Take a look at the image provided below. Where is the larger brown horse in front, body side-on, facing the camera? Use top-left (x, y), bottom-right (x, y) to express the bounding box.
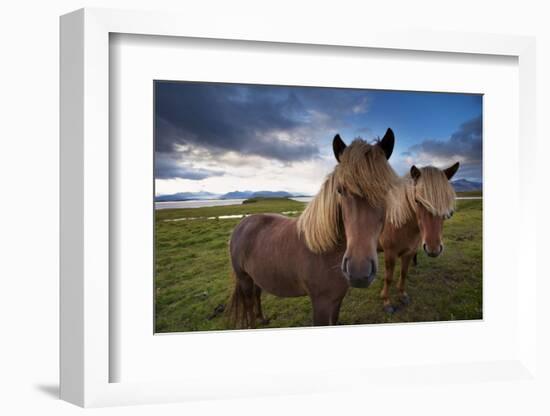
top-left (229, 129), bottom-right (398, 328)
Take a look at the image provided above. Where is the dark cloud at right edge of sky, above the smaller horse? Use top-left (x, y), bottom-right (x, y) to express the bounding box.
top-left (406, 116), bottom-right (482, 179)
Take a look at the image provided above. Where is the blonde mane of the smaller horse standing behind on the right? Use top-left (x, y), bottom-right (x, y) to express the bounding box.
top-left (386, 166), bottom-right (456, 227)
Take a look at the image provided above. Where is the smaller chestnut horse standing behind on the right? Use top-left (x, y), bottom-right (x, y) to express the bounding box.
top-left (378, 162), bottom-right (459, 313)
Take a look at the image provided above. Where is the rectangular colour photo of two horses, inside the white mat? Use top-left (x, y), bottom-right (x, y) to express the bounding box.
top-left (153, 80), bottom-right (483, 333)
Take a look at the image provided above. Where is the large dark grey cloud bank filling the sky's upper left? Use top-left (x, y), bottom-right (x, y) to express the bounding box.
top-left (155, 82), bottom-right (374, 173)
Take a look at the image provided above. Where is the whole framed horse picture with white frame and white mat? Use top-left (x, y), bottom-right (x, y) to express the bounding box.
top-left (61, 9), bottom-right (538, 406)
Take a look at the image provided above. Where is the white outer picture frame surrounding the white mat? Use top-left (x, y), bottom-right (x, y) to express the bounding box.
top-left (60, 9), bottom-right (538, 407)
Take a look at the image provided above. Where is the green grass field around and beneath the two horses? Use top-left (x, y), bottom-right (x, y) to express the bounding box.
top-left (155, 196), bottom-right (483, 332)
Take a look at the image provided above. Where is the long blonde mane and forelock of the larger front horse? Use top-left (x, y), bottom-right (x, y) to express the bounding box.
top-left (297, 139), bottom-right (399, 253)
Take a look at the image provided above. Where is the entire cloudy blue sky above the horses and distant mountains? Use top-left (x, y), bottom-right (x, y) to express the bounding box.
top-left (155, 81), bottom-right (482, 195)
